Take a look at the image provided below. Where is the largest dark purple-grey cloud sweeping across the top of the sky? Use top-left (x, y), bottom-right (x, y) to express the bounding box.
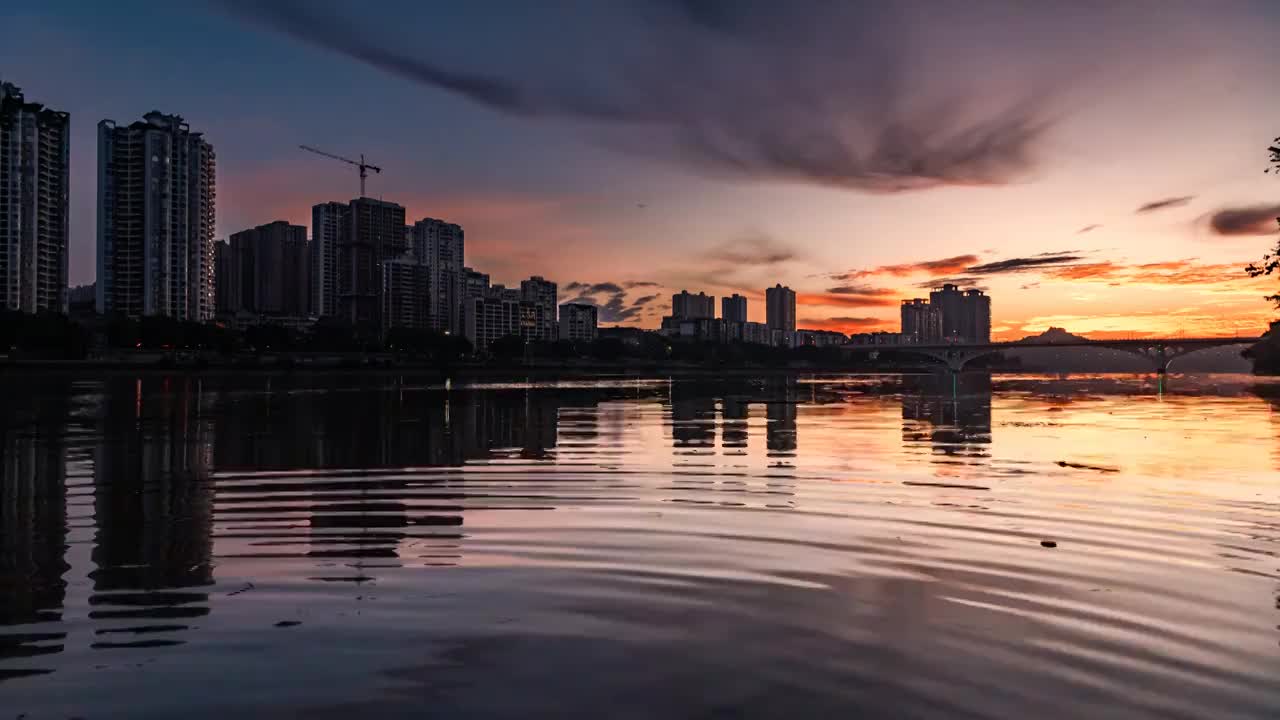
top-left (216, 0), bottom-right (1092, 192)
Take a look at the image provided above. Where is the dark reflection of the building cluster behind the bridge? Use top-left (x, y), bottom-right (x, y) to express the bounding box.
top-left (902, 373), bottom-right (992, 459)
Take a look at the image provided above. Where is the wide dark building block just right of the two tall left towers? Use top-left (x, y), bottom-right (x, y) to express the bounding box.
top-left (216, 220), bottom-right (311, 318)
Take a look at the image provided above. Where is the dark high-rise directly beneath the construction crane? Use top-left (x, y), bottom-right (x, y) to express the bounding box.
top-left (337, 197), bottom-right (406, 332)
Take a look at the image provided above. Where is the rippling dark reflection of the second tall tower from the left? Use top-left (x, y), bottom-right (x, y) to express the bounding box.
top-left (88, 378), bottom-right (214, 650)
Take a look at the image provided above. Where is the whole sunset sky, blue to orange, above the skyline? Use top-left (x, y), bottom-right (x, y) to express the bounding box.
top-left (0, 0), bottom-right (1280, 340)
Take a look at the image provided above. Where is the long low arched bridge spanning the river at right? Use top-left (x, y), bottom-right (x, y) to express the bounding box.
top-left (842, 337), bottom-right (1262, 374)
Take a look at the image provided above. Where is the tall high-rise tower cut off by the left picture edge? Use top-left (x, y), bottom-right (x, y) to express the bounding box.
top-left (0, 82), bottom-right (70, 313)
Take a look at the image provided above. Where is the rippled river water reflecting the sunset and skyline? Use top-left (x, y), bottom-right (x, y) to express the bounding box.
top-left (0, 374), bottom-right (1280, 720)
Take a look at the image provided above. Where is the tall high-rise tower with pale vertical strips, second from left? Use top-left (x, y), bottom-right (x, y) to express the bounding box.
top-left (97, 110), bottom-right (216, 316)
